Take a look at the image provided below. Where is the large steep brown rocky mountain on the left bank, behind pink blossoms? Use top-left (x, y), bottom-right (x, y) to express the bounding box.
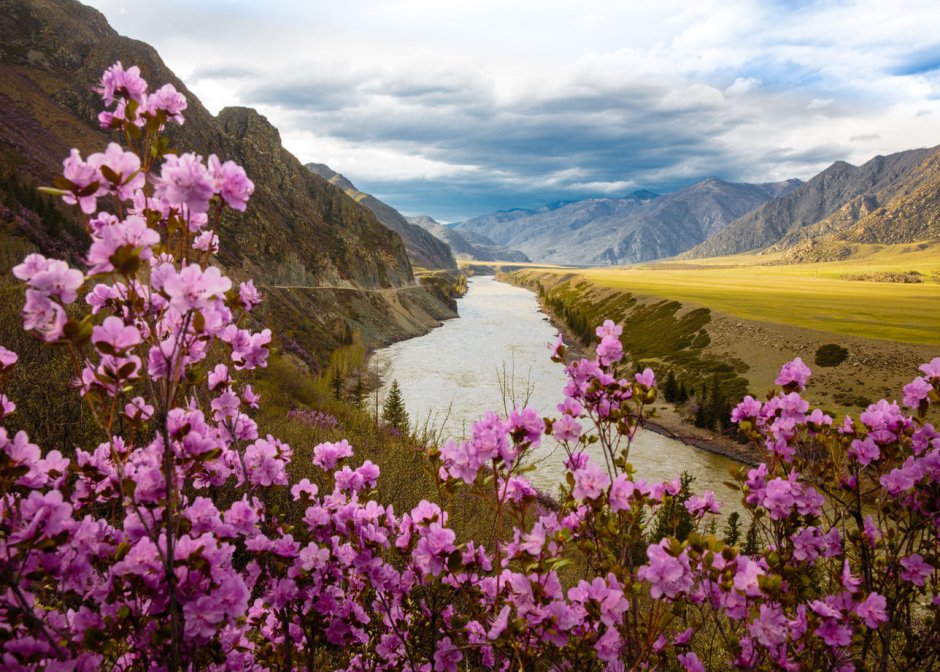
top-left (0, 0), bottom-right (454, 366)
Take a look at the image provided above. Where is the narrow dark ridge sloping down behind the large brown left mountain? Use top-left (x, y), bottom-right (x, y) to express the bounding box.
top-left (306, 163), bottom-right (457, 270)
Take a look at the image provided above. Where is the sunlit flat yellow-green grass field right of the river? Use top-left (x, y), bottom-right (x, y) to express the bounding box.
top-left (510, 242), bottom-right (940, 345)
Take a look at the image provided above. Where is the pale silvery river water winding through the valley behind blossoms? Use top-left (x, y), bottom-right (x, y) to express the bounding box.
top-left (374, 276), bottom-right (741, 513)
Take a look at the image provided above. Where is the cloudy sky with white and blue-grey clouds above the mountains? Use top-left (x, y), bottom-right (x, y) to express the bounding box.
top-left (85, 0), bottom-right (940, 221)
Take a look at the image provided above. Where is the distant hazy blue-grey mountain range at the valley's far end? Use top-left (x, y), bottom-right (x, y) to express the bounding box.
top-left (456, 178), bottom-right (801, 265)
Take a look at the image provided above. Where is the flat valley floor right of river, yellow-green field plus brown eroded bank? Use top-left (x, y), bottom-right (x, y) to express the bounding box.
top-left (494, 243), bottom-right (940, 414)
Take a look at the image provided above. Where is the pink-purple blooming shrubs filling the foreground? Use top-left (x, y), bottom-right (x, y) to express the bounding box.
top-left (0, 63), bottom-right (940, 672)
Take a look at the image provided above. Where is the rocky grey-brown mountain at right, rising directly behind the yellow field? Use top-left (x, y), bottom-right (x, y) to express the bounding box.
top-left (683, 148), bottom-right (940, 258)
